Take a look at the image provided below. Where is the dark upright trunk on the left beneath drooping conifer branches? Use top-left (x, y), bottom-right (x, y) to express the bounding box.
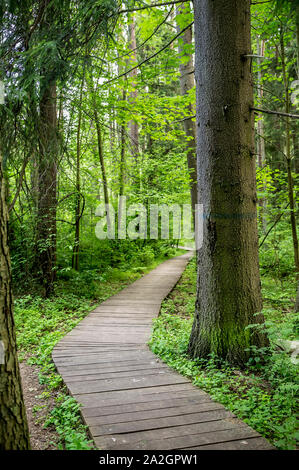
top-left (37, 82), bottom-right (57, 297)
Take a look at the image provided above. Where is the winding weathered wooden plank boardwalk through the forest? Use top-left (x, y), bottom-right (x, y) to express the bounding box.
top-left (53, 252), bottom-right (272, 450)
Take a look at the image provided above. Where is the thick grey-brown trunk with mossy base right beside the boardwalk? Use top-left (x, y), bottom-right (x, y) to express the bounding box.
top-left (189, 0), bottom-right (267, 366)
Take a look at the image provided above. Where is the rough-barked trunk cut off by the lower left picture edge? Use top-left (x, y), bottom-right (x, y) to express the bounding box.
top-left (0, 152), bottom-right (30, 450)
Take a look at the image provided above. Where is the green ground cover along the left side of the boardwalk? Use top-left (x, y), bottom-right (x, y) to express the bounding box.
top-left (14, 244), bottom-right (182, 450)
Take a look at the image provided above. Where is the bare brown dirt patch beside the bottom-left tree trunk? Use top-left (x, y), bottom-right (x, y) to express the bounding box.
top-left (20, 361), bottom-right (58, 450)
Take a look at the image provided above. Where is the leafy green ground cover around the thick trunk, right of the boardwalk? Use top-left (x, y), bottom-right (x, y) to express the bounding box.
top-left (149, 259), bottom-right (299, 449)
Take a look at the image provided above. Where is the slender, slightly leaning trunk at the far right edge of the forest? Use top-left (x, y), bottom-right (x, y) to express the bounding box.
top-left (280, 25), bottom-right (299, 273)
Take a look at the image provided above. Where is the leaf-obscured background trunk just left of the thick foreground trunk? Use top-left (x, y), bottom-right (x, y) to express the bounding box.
top-left (177, 3), bottom-right (198, 218)
